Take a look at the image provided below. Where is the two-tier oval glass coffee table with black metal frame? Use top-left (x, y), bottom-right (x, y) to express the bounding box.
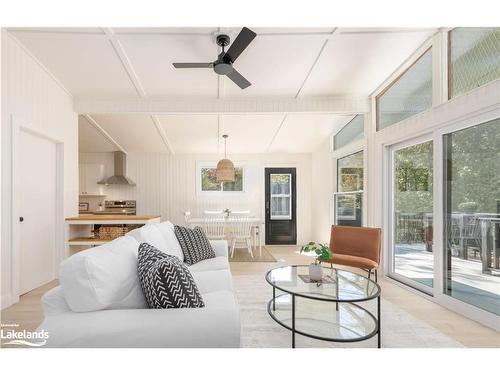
top-left (266, 266), bottom-right (380, 348)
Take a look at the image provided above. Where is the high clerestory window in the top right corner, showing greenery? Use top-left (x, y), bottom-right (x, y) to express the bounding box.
top-left (448, 27), bottom-right (500, 99)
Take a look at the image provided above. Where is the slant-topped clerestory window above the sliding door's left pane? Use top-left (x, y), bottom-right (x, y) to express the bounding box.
top-left (377, 49), bottom-right (432, 130)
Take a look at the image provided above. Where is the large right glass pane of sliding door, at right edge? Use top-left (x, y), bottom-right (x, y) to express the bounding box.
top-left (443, 119), bottom-right (500, 315)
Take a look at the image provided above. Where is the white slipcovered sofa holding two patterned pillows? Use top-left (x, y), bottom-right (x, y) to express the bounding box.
top-left (38, 222), bottom-right (240, 348)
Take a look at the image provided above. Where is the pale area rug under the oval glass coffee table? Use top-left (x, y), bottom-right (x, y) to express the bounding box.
top-left (234, 275), bottom-right (463, 348)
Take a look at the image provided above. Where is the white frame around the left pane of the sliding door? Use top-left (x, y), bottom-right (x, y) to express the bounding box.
top-left (384, 134), bottom-right (439, 296)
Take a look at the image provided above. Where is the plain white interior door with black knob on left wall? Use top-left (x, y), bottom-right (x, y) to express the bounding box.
top-left (19, 131), bottom-right (57, 294)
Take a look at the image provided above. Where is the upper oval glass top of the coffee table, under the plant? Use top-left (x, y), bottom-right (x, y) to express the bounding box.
top-left (266, 265), bottom-right (380, 302)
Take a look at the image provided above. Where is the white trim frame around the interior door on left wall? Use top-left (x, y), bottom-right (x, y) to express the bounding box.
top-left (10, 116), bottom-right (64, 304)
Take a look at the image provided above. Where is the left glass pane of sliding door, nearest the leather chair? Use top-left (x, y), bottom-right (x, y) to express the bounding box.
top-left (389, 141), bottom-right (434, 293)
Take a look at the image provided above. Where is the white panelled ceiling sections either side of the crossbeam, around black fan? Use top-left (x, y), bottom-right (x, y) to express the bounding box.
top-left (8, 27), bottom-right (436, 153)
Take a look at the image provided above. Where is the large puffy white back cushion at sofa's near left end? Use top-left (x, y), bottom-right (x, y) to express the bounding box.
top-left (59, 236), bottom-right (147, 312)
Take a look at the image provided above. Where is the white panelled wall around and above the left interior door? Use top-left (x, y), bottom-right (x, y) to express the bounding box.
top-left (1, 30), bottom-right (78, 308)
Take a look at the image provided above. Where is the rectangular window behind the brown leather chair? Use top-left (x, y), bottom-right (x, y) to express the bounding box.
top-left (334, 151), bottom-right (363, 227)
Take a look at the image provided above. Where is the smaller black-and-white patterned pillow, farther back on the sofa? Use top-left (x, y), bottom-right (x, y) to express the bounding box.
top-left (174, 225), bottom-right (215, 265)
